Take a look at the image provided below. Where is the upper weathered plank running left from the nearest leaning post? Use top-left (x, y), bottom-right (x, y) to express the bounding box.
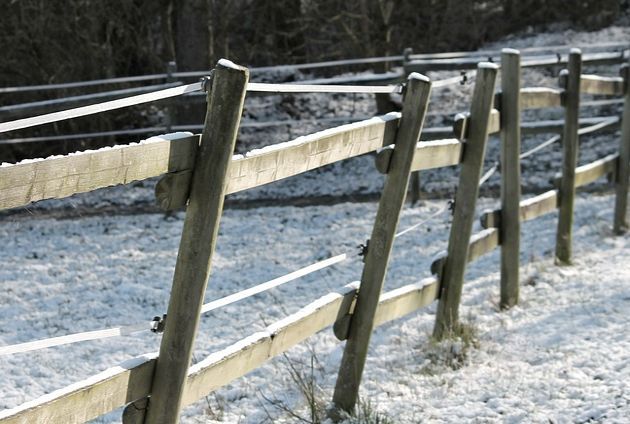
top-left (0, 133), bottom-right (199, 210)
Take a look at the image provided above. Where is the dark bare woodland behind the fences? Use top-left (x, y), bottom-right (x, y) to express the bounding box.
top-left (0, 0), bottom-right (630, 160)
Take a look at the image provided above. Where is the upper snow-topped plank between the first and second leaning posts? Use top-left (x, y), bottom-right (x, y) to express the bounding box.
top-left (156, 112), bottom-right (400, 210)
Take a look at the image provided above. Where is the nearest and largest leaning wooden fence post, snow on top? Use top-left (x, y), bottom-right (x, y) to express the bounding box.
top-left (145, 60), bottom-right (249, 424)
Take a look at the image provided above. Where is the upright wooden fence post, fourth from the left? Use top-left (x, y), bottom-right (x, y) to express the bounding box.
top-left (500, 49), bottom-right (521, 309)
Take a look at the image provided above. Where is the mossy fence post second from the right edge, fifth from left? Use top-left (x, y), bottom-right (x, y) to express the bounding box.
top-left (556, 49), bottom-right (582, 265)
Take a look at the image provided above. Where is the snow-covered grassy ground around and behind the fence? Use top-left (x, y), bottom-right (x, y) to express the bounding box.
top-left (0, 18), bottom-right (630, 423)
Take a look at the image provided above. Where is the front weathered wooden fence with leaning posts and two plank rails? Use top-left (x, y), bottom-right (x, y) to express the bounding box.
top-left (0, 50), bottom-right (630, 424)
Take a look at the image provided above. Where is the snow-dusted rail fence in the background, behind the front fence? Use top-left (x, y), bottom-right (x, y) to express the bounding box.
top-left (0, 43), bottom-right (630, 145)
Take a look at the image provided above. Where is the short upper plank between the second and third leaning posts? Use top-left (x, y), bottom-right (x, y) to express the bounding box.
top-left (375, 138), bottom-right (463, 174)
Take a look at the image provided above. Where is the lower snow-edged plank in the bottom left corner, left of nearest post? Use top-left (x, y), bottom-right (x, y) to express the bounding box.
top-left (0, 354), bottom-right (157, 424)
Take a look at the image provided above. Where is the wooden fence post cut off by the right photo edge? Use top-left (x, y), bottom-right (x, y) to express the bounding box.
top-left (613, 64), bottom-right (630, 234)
